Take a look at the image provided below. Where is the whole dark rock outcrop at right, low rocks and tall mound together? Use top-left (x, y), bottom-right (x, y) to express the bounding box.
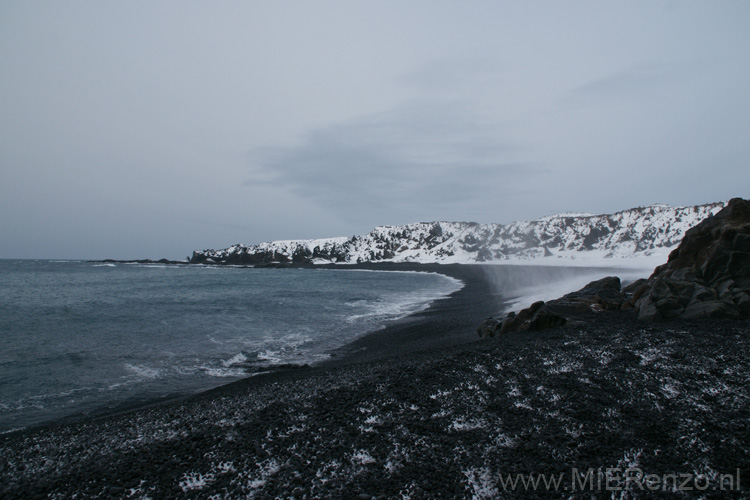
top-left (488, 198), bottom-right (750, 338)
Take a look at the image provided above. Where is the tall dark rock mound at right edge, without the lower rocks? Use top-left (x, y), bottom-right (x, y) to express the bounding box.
top-left (634, 198), bottom-right (750, 321)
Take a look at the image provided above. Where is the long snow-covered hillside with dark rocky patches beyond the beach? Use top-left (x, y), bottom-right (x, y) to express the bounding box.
top-left (190, 202), bottom-right (725, 267)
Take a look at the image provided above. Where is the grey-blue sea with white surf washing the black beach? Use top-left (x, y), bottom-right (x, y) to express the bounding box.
top-left (0, 260), bottom-right (462, 432)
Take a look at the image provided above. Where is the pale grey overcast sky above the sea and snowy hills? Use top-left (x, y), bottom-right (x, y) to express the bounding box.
top-left (0, 0), bottom-right (750, 259)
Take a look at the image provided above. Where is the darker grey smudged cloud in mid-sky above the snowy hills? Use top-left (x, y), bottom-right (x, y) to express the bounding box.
top-left (247, 102), bottom-right (537, 221)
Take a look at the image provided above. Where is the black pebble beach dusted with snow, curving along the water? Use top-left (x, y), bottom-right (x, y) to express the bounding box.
top-left (0, 265), bottom-right (750, 499)
